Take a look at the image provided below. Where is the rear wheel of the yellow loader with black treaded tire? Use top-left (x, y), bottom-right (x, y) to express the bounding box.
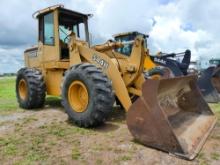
top-left (16, 68), bottom-right (46, 109)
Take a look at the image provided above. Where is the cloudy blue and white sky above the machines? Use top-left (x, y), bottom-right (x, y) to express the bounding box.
top-left (0, 0), bottom-right (220, 73)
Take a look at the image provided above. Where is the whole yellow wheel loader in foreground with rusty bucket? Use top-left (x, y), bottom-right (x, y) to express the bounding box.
top-left (16, 6), bottom-right (216, 159)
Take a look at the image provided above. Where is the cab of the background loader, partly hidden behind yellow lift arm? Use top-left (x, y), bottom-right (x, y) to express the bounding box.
top-left (113, 31), bottom-right (148, 56)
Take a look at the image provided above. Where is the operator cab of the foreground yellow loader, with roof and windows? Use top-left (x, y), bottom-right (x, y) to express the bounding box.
top-left (34, 5), bottom-right (90, 61)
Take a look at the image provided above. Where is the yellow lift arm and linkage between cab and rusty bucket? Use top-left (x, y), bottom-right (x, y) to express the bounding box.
top-left (69, 34), bottom-right (145, 111)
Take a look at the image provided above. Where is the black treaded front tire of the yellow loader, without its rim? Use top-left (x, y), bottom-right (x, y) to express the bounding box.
top-left (62, 63), bottom-right (115, 127)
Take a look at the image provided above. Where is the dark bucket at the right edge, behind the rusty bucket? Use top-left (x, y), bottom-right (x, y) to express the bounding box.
top-left (197, 67), bottom-right (220, 103)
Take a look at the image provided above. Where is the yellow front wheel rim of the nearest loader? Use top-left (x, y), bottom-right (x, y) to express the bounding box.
top-left (68, 81), bottom-right (89, 112)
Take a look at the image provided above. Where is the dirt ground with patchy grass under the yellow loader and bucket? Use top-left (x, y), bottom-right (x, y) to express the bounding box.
top-left (0, 102), bottom-right (220, 165)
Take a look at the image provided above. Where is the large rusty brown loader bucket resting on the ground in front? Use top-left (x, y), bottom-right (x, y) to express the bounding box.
top-left (126, 76), bottom-right (216, 160)
